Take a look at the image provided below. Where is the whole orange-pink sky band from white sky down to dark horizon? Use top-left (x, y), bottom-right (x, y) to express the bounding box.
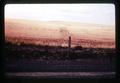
top-left (5, 19), bottom-right (115, 48)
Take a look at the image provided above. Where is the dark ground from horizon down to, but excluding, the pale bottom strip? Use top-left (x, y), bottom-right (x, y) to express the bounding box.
top-left (5, 43), bottom-right (116, 72)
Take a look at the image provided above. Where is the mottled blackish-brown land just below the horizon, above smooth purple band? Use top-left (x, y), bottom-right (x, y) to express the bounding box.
top-left (5, 39), bottom-right (116, 60)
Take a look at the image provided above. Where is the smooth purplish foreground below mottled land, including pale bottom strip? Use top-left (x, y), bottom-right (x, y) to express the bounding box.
top-left (5, 59), bottom-right (115, 78)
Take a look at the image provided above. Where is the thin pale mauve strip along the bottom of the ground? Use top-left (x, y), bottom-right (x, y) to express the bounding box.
top-left (6, 72), bottom-right (115, 79)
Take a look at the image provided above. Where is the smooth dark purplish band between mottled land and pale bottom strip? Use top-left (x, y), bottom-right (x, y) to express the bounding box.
top-left (5, 59), bottom-right (115, 72)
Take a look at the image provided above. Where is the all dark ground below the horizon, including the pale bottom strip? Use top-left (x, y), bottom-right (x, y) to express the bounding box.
top-left (4, 43), bottom-right (116, 78)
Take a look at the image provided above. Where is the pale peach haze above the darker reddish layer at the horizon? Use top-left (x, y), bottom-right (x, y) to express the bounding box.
top-left (5, 19), bottom-right (115, 48)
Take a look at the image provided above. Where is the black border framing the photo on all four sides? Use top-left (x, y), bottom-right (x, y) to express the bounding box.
top-left (0, 0), bottom-right (120, 83)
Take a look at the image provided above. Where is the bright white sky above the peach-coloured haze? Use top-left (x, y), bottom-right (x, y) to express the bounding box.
top-left (5, 4), bottom-right (115, 25)
